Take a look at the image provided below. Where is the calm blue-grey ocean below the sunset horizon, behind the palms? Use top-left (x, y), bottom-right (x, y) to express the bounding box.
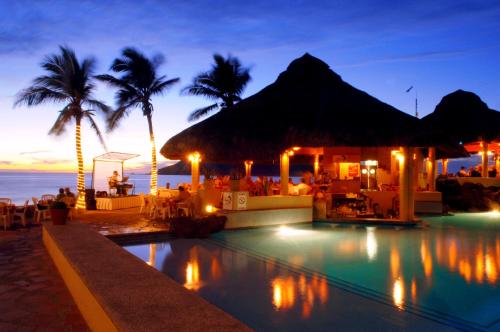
top-left (0, 156), bottom-right (484, 204)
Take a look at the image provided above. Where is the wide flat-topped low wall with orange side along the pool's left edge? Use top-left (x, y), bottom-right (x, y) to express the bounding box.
top-left (43, 222), bottom-right (251, 331)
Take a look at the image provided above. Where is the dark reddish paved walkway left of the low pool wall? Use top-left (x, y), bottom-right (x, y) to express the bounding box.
top-left (0, 226), bottom-right (88, 332)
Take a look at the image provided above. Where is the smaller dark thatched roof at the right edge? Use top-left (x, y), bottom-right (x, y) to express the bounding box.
top-left (422, 90), bottom-right (500, 144)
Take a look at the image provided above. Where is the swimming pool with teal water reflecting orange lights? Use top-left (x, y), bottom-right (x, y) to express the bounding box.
top-left (124, 213), bottom-right (500, 331)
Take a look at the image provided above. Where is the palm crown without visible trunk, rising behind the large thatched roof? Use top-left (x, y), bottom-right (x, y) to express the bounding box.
top-left (182, 54), bottom-right (251, 121)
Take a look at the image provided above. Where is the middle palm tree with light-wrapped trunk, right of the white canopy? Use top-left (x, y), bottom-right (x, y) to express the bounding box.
top-left (96, 47), bottom-right (179, 194)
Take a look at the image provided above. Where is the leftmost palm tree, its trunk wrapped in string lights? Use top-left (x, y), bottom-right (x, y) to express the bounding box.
top-left (14, 46), bottom-right (111, 208)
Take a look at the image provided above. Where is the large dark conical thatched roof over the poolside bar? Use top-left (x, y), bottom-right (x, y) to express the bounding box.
top-left (161, 54), bottom-right (428, 162)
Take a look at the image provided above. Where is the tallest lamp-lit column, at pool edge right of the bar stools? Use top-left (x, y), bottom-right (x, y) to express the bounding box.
top-left (398, 147), bottom-right (415, 221)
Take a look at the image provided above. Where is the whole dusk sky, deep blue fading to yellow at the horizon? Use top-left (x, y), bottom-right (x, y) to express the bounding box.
top-left (0, 0), bottom-right (500, 171)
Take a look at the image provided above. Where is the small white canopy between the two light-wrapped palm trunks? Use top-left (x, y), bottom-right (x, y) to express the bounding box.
top-left (92, 152), bottom-right (139, 191)
